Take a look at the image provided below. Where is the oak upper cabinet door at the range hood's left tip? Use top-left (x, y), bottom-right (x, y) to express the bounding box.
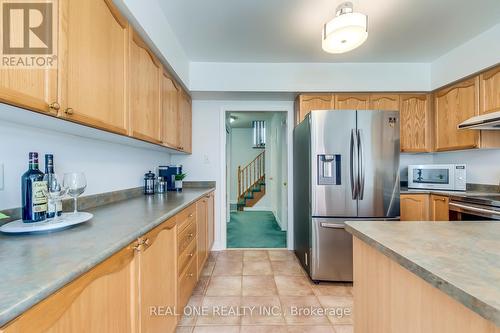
top-left (435, 76), bottom-right (479, 151)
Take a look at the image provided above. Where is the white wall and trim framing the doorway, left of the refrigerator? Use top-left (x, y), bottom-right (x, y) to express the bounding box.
top-left (172, 100), bottom-right (293, 249)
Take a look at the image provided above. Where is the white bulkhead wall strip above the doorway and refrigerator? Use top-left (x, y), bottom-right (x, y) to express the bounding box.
top-left (189, 62), bottom-right (431, 92)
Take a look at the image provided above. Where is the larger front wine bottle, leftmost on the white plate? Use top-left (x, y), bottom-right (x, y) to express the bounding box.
top-left (21, 152), bottom-right (47, 223)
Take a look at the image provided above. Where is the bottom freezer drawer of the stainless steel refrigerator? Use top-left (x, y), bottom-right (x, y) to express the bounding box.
top-left (310, 218), bottom-right (353, 282)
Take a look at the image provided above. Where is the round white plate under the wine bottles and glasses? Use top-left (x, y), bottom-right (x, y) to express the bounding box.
top-left (0, 212), bottom-right (94, 234)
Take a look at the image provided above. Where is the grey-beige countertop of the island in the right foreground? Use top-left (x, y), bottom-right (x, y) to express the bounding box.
top-left (346, 221), bottom-right (500, 326)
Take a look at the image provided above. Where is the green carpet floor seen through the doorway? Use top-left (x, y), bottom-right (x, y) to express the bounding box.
top-left (227, 211), bottom-right (286, 248)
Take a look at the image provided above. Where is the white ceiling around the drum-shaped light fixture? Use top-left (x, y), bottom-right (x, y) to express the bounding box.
top-left (159, 0), bottom-right (500, 62)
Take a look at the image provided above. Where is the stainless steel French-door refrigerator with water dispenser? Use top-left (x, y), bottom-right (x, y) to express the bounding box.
top-left (293, 110), bottom-right (400, 281)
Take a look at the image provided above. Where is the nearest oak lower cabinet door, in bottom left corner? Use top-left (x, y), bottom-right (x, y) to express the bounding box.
top-left (2, 246), bottom-right (138, 333)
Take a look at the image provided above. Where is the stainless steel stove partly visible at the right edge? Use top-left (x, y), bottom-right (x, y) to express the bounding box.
top-left (449, 194), bottom-right (500, 221)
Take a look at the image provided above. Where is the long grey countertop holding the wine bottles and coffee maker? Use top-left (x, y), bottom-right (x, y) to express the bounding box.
top-left (0, 186), bottom-right (215, 326)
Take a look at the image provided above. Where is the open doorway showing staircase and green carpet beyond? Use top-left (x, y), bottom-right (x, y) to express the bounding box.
top-left (225, 111), bottom-right (288, 248)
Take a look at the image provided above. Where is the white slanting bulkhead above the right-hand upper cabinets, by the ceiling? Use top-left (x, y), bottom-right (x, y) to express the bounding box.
top-left (431, 23), bottom-right (500, 89)
